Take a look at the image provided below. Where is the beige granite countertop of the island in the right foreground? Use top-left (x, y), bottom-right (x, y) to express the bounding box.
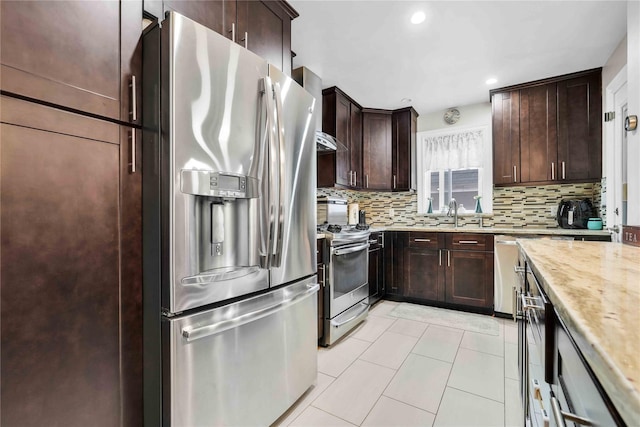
top-left (518, 240), bottom-right (640, 426)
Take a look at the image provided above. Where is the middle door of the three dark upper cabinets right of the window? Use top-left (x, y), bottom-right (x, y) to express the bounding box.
top-left (519, 83), bottom-right (558, 182)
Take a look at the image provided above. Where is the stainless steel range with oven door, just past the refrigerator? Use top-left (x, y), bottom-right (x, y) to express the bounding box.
top-left (318, 198), bottom-right (371, 346)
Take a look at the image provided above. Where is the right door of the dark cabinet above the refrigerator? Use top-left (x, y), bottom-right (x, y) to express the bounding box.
top-left (236, 0), bottom-right (292, 75)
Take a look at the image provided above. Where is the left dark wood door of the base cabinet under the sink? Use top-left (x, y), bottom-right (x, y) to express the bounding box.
top-left (404, 248), bottom-right (444, 301)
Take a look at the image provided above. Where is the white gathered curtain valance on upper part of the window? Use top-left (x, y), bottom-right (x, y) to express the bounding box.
top-left (421, 129), bottom-right (484, 172)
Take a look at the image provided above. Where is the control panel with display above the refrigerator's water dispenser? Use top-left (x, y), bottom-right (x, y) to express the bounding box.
top-left (180, 170), bottom-right (260, 199)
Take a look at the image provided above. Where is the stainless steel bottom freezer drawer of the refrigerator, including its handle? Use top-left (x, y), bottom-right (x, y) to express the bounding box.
top-left (162, 276), bottom-right (319, 427)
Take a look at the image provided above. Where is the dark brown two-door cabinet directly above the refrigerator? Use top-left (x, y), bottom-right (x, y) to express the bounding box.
top-left (162, 0), bottom-right (298, 75)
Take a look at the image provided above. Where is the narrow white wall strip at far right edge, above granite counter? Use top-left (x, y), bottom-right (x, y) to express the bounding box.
top-left (627, 1), bottom-right (640, 225)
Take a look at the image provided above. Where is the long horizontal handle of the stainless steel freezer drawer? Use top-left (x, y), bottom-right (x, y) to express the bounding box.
top-left (182, 283), bottom-right (320, 342)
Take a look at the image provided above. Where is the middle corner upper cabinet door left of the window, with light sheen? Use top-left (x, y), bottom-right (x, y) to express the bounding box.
top-left (362, 112), bottom-right (392, 190)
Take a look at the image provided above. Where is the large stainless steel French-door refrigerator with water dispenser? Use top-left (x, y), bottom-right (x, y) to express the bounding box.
top-left (143, 12), bottom-right (318, 426)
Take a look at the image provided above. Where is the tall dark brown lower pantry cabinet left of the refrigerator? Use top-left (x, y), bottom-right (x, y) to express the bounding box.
top-left (0, 97), bottom-right (142, 427)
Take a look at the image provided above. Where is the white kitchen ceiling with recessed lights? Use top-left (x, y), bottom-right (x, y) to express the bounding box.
top-left (289, 0), bottom-right (627, 114)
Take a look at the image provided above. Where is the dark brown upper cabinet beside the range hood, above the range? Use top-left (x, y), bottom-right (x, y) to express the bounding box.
top-left (318, 86), bottom-right (362, 188)
